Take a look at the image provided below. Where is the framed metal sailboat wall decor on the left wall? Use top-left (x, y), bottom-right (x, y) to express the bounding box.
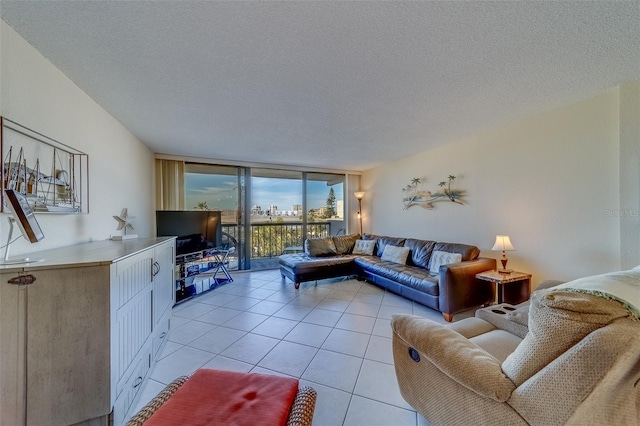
top-left (0, 117), bottom-right (89, 214)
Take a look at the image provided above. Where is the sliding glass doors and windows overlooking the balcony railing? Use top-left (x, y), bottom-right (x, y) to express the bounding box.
top-left (158, 160), bottom-right (347, 270)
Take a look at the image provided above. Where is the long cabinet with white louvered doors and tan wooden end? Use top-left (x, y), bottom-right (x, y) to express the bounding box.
top-left (0, 238), bottom-right (175, 426)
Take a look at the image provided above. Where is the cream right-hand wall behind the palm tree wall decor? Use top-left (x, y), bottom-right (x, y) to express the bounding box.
top-left (362, 89), bottom-right (640, 286)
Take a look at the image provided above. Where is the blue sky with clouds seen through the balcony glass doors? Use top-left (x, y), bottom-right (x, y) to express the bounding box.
top-left (185, 173), bottom-right (344, 210)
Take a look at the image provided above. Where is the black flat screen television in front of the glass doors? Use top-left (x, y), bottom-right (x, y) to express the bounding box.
top-left (156, 210), bottom-right (222, 254)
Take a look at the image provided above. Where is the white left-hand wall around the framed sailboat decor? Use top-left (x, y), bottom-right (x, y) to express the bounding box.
top-left (0, 21), bottom-right (155, 255)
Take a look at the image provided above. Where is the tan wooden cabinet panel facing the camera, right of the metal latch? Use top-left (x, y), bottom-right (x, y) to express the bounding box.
top-left (26, 266), bottom-right (111, 425)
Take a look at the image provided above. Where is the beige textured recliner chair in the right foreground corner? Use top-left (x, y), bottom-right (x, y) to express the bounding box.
top-left (391, 273), bottom-right (640, 426)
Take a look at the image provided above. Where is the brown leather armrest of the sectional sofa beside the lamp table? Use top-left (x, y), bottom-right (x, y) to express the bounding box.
top-left (438, 257), bottom-right (496, 314)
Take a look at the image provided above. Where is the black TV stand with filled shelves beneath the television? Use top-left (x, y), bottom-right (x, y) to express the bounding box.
top-left (175, 248), bottom-right (233, 304)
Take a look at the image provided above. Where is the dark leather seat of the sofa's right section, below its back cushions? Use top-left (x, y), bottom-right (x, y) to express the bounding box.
top-left (355, 256), bottom-right (439, 296)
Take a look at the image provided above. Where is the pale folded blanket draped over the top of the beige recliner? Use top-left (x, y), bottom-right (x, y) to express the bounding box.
top-left (555, 269), bottom-right (640, 320)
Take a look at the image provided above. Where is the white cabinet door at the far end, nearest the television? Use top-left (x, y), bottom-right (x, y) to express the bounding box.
top-left (153, 240), bottom-right (175, 327)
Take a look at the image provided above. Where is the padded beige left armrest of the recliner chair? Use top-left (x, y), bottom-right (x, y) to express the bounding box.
top-left (391, 315), bottom-right (515, 402)
